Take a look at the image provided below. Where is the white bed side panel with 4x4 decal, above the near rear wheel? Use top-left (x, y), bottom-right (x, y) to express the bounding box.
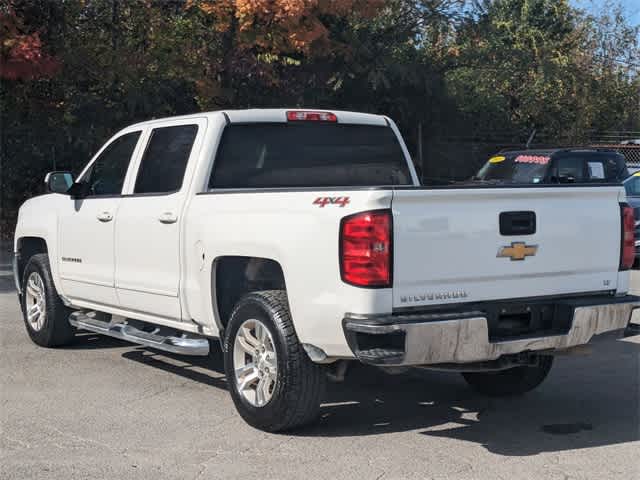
top-left (185, 190), bottom-right (392, 357)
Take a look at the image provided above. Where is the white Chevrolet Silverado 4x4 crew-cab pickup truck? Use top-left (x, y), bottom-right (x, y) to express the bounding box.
top-left (14, 109), bottom-right (640, 431)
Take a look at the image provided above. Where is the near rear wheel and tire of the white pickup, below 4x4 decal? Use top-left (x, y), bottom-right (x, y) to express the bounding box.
top-left (224, 290), bottom-right (326, 432)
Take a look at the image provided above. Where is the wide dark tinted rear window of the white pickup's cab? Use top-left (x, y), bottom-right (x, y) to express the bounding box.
top-left (209, 123), bottom-right (411, 189)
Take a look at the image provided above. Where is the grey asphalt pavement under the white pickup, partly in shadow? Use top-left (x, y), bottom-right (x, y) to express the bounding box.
top-left (0, 248), bottom-right (640, 480)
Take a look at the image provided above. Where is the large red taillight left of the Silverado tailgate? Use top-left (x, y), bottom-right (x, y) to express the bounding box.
top-left (340, 210), bottom-right (393, 288)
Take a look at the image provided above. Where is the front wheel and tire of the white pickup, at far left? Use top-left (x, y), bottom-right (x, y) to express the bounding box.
top-left (21, 253), bottom-right (75, 347)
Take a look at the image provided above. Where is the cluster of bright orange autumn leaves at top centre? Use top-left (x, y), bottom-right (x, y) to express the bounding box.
top-left (187, 0), bottom-right (384, 55)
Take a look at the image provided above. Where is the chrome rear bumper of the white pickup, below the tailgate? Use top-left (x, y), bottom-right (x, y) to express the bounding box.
top-left (343, 295), bottom-right (640, 366)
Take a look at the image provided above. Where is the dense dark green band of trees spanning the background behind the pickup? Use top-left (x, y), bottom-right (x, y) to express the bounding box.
top-left (0, 0), bottom-right (640, 236)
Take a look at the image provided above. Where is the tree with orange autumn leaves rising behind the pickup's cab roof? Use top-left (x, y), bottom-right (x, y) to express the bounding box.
top-left (186, 0), bottom-right (384, 109)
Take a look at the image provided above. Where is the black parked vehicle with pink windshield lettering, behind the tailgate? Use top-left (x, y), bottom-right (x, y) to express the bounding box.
top-left (474, 149), bottom-right (629, 184)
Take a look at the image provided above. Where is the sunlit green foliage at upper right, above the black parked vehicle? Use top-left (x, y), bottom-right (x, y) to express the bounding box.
top-left (446, 0), bottom-right (639, 141)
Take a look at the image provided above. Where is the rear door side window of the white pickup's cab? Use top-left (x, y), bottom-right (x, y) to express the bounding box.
top-left (133, 125), bottom-right (198, 194)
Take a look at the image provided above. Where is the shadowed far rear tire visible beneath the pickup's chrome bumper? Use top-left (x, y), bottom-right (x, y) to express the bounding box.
top-left (462, 355), bottom-right (553, 397)
